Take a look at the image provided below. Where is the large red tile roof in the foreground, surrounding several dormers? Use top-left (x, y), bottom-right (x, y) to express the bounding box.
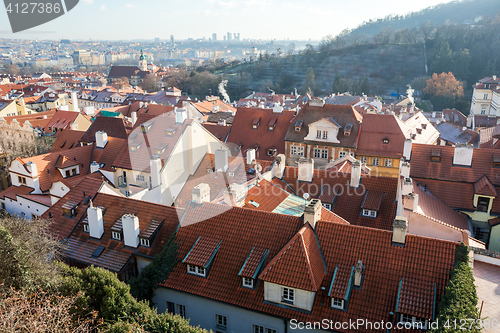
top-left (161, 203), bottom-right (458, 331)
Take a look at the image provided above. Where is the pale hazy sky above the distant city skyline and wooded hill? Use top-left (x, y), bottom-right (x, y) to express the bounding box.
top-left (0, 0), bottom-right (451, 40)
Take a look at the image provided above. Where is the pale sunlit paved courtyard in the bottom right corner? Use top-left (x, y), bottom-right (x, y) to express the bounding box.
top-left (474, 260), bottom-right (500, 333)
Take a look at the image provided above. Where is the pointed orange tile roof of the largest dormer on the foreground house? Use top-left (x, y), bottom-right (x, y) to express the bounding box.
top-left (259, 223), bottom-right (327, 292)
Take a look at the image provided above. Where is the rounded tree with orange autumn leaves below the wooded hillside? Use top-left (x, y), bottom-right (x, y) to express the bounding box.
top-left (424, 72), bottom-right (464, 110)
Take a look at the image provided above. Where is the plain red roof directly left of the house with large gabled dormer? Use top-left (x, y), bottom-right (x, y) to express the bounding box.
top-left (227, 107), bottom-right (295, 161)
